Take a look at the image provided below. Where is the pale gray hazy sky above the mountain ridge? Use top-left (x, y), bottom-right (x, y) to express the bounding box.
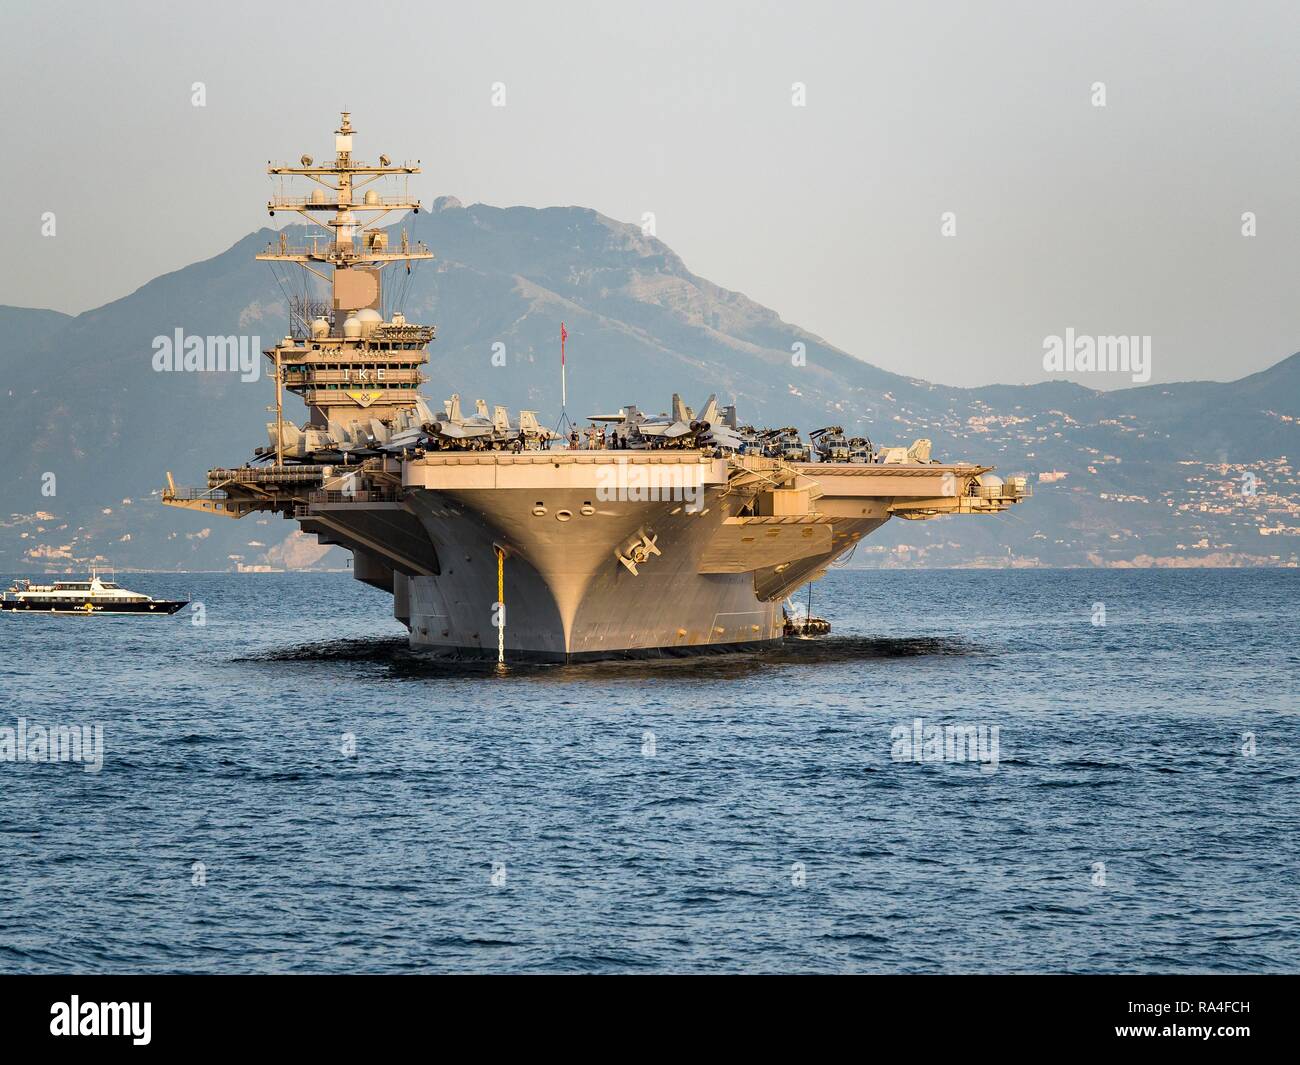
top-left (0, 0), bottom-right (1300, 388)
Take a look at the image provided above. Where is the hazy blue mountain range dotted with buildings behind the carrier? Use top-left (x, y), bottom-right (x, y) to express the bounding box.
top-left (0, 196), bottom-right (1300, 572)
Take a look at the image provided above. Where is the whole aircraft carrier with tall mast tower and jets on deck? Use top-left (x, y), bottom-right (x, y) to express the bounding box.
top-left (163, 113), bottom-right (1028, 662)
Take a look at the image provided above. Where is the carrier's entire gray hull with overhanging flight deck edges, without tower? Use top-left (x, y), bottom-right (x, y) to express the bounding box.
top-left (295, 451), bottom-right (1013, 662)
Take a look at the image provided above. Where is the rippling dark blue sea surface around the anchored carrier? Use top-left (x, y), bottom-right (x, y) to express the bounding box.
top-left (0, 570), bottom-right (1300, 973)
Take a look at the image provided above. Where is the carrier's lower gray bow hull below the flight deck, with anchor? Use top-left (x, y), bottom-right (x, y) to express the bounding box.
top-left (407, 489), bottom-right (783, 661)
